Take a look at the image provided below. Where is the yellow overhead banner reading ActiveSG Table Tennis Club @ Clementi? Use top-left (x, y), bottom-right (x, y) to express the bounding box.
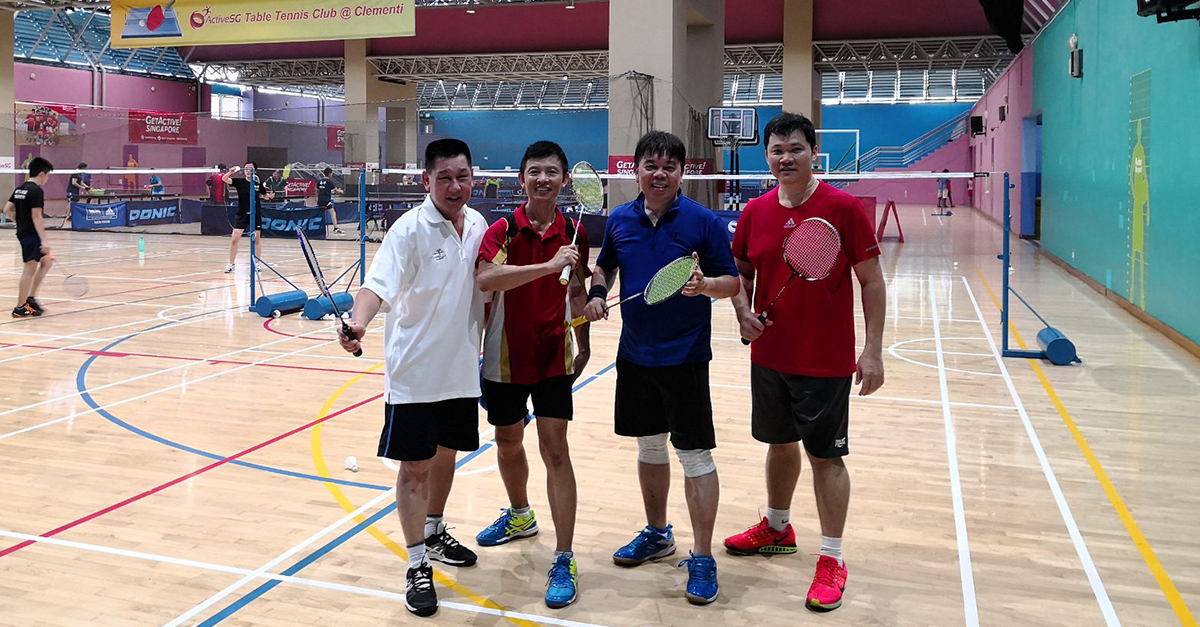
top-left (112, 0), bottom-right (416, 48)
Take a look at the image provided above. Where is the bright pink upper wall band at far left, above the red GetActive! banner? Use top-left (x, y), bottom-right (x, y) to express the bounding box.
top-left (13, 64), bottom-right (196, 112)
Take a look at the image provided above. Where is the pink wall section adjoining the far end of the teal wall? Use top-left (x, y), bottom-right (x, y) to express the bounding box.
top-left (955, 46), bottom-right (1034, 231)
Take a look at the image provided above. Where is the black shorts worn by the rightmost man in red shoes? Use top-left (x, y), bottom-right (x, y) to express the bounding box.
top-left (750, 364), bottom-right (853, 458)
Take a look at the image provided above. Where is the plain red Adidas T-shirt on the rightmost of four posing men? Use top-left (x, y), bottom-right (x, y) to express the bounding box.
top-left (733, 183), bottom-right (880, 377)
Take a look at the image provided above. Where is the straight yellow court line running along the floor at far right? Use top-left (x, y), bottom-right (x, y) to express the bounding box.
top-left (979, 265), bottom-right (1200, 627)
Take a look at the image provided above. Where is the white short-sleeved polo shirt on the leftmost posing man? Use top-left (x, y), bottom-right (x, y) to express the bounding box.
top-left (364, 196), bottom-right (487, 405)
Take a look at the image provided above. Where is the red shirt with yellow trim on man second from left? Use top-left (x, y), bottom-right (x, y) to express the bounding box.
top-left (475, 204), bottom-right (588, 386)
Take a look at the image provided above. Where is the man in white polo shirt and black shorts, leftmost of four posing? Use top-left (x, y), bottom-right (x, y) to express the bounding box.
top-left (341, 139), bottom-right (487, 616)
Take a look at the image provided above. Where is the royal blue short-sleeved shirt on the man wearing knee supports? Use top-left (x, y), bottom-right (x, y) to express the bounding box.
top-left (596, 190), bottom-right (738, 366)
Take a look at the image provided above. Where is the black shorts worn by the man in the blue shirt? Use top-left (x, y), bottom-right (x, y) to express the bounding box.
top-left (613, 357), bottom-right (716, 450)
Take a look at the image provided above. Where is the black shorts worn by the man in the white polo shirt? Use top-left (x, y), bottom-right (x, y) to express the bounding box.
top-left (378, 398), bottom-right (479, 461)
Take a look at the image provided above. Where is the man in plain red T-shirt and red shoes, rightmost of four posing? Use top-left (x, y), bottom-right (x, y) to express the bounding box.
top-left (725, 113), bottom-right (887, 610)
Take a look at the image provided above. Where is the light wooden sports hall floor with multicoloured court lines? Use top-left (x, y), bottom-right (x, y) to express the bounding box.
top-left (0, 205), bottom-right (1200, 627)
